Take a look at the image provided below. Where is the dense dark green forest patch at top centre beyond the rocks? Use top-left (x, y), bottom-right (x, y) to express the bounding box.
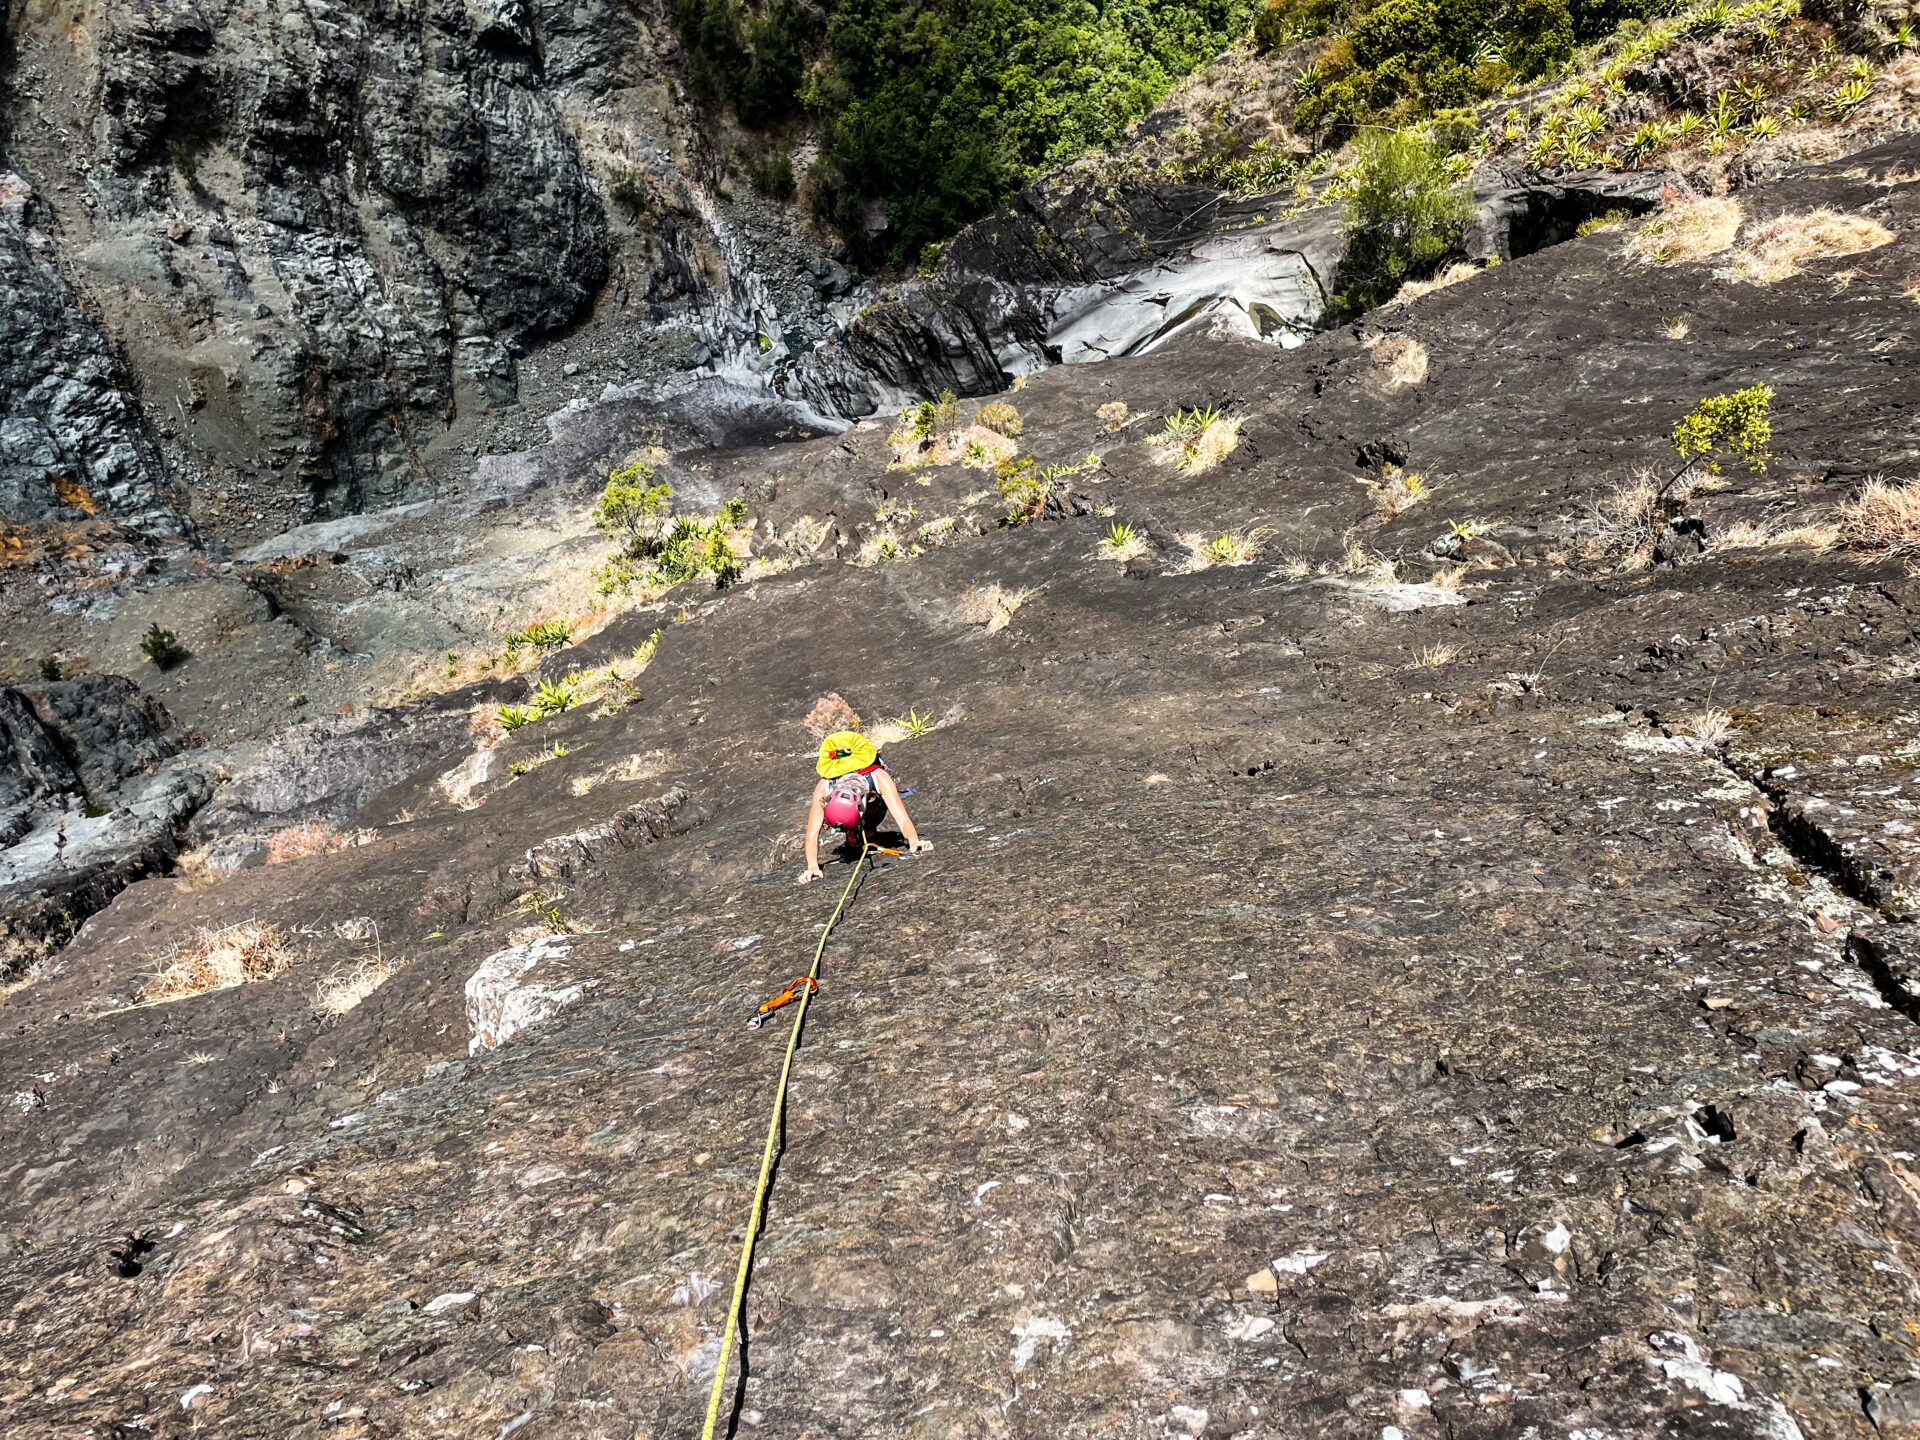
top-left (674, 0), bottom-right (1256, 265)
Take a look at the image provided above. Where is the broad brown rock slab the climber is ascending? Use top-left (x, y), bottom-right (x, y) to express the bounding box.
top-left (0, 126), bottom-right (1920, 1440)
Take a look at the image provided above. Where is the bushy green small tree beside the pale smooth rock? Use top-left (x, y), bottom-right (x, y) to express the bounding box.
top-left (1338, 131), bottom-right (1473, 315)
